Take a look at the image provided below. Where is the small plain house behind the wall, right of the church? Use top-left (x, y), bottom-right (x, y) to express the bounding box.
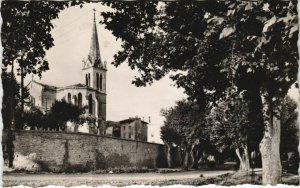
top-left (120, 118), bottom-right (148, 142)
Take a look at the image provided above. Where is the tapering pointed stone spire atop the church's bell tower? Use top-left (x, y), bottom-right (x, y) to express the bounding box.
top-left (88, 8), bottom-right (102, 67)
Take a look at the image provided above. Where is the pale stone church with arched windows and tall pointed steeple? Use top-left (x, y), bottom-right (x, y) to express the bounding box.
top-left (27, 13), bottom-right (107, 133)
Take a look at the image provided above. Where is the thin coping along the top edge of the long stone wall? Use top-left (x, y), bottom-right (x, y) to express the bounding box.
top-left (3, 129), bottom-right (164, 146)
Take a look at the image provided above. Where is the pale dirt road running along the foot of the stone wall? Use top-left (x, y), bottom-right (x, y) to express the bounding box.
top-left (3, 171), bottom-right (232, 187)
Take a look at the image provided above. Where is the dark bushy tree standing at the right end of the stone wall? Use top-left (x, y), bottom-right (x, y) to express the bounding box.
top-left (161, 100), bottom-right (208, 170)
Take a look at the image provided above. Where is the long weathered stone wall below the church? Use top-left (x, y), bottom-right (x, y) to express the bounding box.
top-left (2, 130), bottom-right (166, 172)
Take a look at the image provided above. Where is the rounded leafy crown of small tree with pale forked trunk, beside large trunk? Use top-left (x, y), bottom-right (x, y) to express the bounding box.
top-left (208, 92), bottom-right (253, 152)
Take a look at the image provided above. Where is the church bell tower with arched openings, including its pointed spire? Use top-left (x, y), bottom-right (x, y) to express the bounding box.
top-left (82, 9), bottom-right (107, 121)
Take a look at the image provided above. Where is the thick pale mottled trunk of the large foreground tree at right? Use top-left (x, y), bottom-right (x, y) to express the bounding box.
top-left (260, 100), bottom-right (282, 185)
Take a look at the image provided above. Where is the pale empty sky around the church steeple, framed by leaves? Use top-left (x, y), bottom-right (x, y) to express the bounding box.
top-left (27, 3), bottom-right (299, 142)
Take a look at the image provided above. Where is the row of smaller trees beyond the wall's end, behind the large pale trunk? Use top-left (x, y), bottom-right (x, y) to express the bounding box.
top-left (161, 96), bottom-right (298, 171)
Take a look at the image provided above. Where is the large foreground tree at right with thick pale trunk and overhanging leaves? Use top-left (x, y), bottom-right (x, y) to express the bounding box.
top-left (220, 1), bottom-right (298, 184)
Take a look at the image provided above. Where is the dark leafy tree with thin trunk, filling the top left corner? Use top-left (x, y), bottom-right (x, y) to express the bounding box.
top-left (1, 1), bottom-right (82, 125)
